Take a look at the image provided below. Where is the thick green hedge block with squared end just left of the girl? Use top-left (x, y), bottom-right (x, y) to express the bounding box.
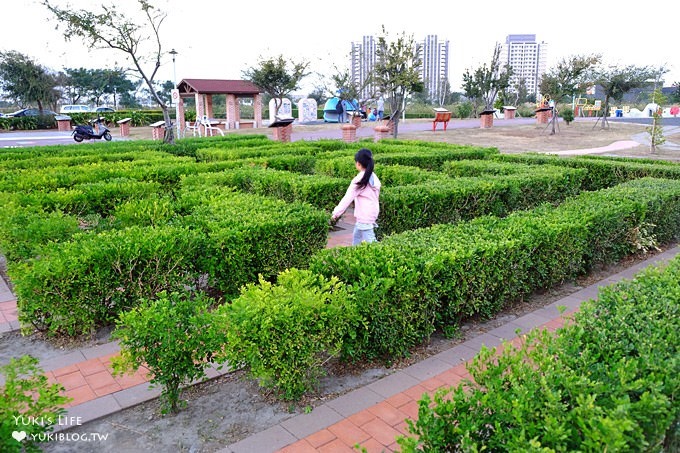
top-left (178, 188), bottom-right (329, 295)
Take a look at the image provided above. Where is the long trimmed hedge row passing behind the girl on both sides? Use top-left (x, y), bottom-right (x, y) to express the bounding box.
top-left (183, 162), bottom-right (584, 237)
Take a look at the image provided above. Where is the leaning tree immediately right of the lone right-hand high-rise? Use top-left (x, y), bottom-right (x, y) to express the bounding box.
top-left (539, 55), bottom-right (602, 102)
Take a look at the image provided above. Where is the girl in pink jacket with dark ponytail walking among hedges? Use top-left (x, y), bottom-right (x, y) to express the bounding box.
top-left (331, 148), bottom-right (380, 245)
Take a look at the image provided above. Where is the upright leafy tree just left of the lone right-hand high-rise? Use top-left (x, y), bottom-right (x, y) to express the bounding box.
top-left (463, 43), bottom-right (512, 116)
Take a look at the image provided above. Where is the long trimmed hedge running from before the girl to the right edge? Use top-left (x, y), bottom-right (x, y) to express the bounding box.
top-left (310, 179), bottom-right (680, 358)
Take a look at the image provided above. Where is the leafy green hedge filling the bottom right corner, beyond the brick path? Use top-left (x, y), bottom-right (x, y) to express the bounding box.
top-left (399, 254), bottom-right (680, 452)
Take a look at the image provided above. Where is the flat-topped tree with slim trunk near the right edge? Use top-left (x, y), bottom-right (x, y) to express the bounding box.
top-left (593, 66), bottom-right (655, 129)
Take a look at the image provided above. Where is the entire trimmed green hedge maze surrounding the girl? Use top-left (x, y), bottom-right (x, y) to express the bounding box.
top-left (0, 135), bottom-right (680, 445)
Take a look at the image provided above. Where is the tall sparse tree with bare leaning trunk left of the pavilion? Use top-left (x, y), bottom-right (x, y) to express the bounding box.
top-left (42, 0), bottom-right (175, 143)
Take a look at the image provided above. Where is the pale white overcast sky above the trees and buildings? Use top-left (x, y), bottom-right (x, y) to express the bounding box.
top-left (0, 0), bottom-right (680, 96)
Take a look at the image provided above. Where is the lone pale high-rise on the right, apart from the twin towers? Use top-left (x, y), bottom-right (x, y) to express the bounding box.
top-left (500, 35), bottom-right (548, 96)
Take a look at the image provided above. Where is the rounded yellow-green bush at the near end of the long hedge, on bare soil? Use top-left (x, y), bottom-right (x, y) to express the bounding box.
top-left (217, 269), bottom-right (360, 399)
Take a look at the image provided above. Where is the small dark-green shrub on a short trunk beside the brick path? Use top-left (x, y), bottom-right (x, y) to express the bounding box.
top-left (111, 292), bottom-right (223, 413)
